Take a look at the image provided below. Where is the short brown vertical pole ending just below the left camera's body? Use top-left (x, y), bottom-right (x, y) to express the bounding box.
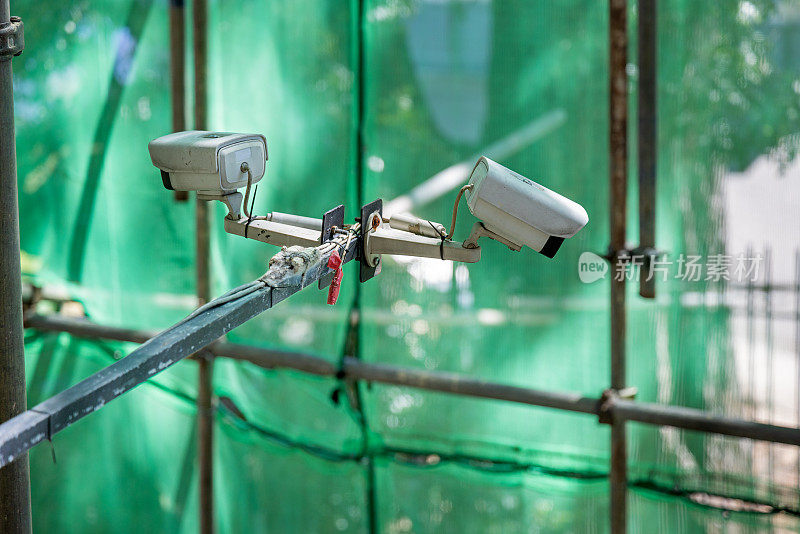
top-left (169, 0), bottom-right (189, 202)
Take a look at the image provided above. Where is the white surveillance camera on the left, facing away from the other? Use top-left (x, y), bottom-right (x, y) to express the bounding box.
top-left (148, 130), bottom-right (267, 215)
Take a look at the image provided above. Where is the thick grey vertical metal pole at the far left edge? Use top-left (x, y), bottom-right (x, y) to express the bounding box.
top-left (0, 0), bottom-right (31, 532)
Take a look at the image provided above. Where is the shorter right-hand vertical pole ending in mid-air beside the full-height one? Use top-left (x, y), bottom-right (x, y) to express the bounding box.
top-left (637, 0), bottom-right (658, 299)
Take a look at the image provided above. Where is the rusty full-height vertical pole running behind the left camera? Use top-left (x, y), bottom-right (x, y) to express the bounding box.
top-left (192, 0), bottom-right (214, 534)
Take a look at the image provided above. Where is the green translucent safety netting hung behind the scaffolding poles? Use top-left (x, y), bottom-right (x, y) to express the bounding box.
top-left (12, 0), bottom-right (800, 533)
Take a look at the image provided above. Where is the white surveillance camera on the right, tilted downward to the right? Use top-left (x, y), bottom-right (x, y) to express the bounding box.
top-left (465, 157), bottom-right (589, 258)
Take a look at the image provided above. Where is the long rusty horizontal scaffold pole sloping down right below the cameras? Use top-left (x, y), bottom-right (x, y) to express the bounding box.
top-left (20, 316), bottom-right (800, 445)
